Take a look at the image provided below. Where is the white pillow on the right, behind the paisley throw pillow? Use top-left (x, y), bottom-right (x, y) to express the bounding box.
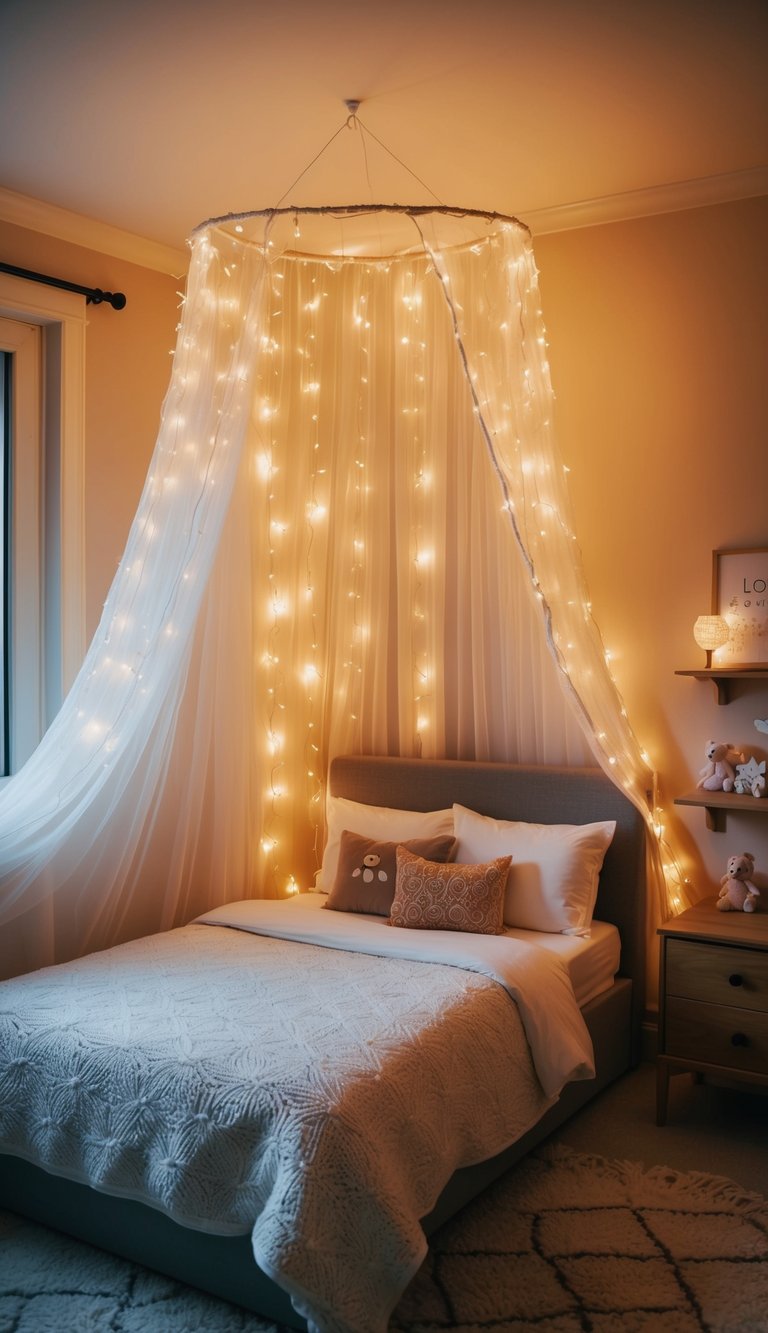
top-left (453, 805), bottom-right (616, 934)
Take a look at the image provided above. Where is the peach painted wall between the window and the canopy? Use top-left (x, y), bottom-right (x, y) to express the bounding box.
top-left (0, 223), bottom-right (181, 639)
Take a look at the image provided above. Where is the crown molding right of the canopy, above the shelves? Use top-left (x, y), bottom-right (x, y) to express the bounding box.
top-left (519, 167), bottom-right (768, 236)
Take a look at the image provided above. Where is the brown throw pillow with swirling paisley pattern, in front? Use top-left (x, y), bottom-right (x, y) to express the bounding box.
top-left (389, 846), bottom-right (512, 934)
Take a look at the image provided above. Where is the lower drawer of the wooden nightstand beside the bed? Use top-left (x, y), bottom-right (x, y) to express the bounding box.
top-left (664, 996), bottom-right (768, 1074)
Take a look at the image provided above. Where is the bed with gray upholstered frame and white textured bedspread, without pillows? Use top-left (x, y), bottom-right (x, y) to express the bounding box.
top-left (0, 756), bottom-right (645, 1333)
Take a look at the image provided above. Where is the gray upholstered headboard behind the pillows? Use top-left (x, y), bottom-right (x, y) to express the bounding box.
top-left (329, 754), bottom-right (645, 1022)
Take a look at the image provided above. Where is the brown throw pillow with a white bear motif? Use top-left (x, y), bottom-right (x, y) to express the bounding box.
top-left (325, 829), bottom-right (456, 916)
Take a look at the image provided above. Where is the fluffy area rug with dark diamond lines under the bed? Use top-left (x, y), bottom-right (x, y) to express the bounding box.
top-left (0, 1146), bottom-right (768, 1333)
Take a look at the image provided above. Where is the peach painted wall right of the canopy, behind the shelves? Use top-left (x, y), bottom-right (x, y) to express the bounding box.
top-left (535, 199), bottom-right (768, 910)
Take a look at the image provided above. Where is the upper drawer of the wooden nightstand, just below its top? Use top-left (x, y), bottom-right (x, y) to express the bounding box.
top-left (667, 940), bottom-right (768, 1012)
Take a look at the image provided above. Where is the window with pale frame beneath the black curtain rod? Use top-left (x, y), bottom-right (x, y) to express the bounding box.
top-left (0, 275), bottom-right (85, 776)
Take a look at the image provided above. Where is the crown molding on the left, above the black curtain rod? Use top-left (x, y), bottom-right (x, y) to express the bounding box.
top-left (0, 185), bottom-right (189, 277)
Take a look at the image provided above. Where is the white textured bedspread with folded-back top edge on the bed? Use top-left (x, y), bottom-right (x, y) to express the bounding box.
top-left (0, 896), bottom-right (592, 1333)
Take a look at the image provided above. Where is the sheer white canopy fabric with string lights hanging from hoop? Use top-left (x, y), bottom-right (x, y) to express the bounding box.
top-left (0, 208), bottom-right (677, 961)
